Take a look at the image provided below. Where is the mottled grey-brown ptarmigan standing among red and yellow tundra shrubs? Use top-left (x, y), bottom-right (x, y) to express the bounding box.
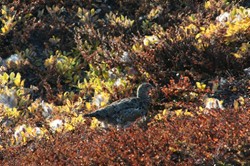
top-left (84, 83), bottom-right (153, 126)
